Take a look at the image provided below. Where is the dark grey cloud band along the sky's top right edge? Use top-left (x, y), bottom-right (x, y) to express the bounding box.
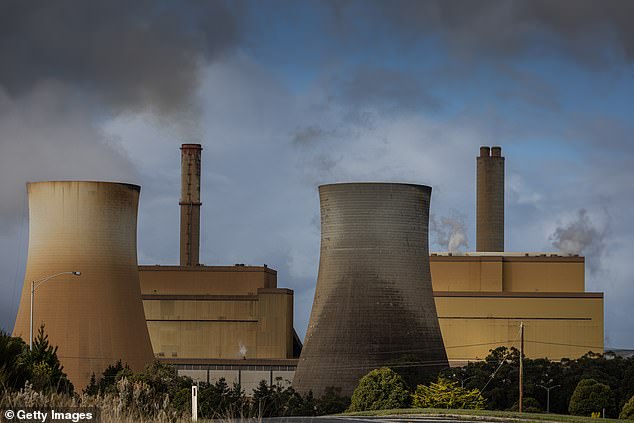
top-left (331, 0), bottom-right (634, 66)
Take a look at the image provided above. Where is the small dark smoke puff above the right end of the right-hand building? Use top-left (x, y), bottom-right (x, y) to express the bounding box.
top-left (549, 209), bottom-right (606, 273)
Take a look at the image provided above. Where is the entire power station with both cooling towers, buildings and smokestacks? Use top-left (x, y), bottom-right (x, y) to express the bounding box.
top-left (13, 144), bottom-right (604, 393)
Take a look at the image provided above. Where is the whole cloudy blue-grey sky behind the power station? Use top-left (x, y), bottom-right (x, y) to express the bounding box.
top-left (0, 0), bottom-right (634, 349)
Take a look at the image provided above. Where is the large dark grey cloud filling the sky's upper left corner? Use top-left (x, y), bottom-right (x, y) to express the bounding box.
top-left (0, 0), bottom-right (239, 112)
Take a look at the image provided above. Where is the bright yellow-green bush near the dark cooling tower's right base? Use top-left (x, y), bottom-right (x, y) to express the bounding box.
top-left (412, 377), bottom-right (486, 410)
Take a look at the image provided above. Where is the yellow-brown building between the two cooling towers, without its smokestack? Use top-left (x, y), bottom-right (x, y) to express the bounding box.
top-left (139, 266), bottom-right (294, 363)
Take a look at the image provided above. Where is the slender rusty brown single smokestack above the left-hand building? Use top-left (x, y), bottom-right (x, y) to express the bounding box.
top-left (178, 144), bottom-right (202, 266)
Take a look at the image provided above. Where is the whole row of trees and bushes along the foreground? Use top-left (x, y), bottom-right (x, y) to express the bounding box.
top-left (0, 327), bottom-right (634, 419)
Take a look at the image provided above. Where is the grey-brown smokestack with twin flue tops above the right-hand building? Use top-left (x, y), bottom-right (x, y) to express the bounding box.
top-left (476, 146), bottom-right (504, 252)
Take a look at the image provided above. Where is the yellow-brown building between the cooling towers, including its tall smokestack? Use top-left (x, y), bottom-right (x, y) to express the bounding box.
top-left (139, 144), bottom-right (301, 393)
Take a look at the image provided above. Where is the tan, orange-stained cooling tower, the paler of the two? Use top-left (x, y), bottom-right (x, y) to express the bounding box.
top-left (13, 181), bottom-right (153, 389)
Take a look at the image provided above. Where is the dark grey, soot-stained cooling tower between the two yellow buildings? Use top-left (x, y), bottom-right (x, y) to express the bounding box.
top-left (293, 183), bottom-right (448, 395)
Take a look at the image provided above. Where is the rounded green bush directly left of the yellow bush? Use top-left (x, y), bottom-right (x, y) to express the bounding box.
top-left (348, 367), bottom-right (410, 411)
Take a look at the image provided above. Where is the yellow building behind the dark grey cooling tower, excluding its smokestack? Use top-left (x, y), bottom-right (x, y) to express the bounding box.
top-left (430, 253), bottom-right (604, 366)
